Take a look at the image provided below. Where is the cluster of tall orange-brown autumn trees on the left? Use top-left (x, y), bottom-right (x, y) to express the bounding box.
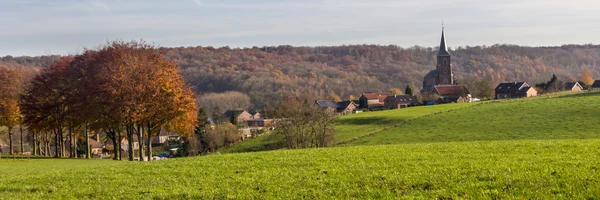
top-left (2, 41), bottom-right (198, 160)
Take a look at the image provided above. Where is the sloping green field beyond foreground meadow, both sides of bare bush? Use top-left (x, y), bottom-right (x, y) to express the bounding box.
top-left (221, 92), bottom-right (600, 153)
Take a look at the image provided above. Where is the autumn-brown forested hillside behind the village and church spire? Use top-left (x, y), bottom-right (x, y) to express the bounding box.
top-left (0, 45), bottom-right (600, 108)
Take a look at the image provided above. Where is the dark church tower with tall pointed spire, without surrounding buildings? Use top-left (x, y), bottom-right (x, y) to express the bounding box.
top-left (436, 26), bottom-right (454, 85)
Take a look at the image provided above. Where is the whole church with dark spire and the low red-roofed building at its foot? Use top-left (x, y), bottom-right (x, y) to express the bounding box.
top-left (421, 27), bottom-right (470, 103)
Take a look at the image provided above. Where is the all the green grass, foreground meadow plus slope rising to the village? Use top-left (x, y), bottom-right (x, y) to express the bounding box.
top-left (0, 92), bottom-right (600, 199)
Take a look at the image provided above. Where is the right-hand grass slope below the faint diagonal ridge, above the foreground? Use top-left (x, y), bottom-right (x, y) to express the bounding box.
top-left (346, 92), bottom-right (600, 145)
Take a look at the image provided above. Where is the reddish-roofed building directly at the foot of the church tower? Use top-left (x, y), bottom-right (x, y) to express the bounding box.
top-left (428, 85), bottom-right (471, 104)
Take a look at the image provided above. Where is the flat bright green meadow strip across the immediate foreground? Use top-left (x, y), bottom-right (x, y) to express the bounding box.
top-left (0, 139), bottom-right (600, 199)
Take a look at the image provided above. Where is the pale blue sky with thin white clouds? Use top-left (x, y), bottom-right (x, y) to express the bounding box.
top-left (0, 0), bottom-right (600, 56)
